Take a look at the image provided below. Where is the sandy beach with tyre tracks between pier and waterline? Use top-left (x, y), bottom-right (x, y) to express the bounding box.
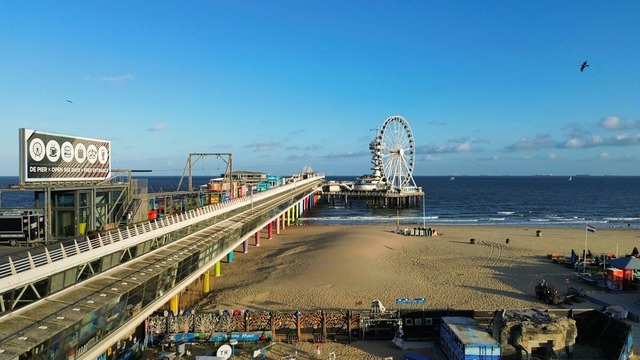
top-left (180, 225), bottom-right (640, 359)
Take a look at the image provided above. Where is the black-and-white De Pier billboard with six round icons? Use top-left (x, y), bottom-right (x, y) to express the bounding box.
top-left (20, 129), bottom-right (111, 183)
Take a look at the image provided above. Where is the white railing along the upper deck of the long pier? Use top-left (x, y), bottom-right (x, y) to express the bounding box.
top-left (0, 177), bottom-right (317, 286)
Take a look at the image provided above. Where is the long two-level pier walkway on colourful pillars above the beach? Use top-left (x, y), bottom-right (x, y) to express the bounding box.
top-left (0, 176), bottom-right (324, 359)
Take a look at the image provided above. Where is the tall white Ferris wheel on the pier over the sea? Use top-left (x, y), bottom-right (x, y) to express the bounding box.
top-left (371, 116), bottom-right (416, 192)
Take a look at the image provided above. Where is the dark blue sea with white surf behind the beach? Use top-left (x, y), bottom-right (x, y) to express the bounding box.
top-left (0, 175), bottom-right (640, 228)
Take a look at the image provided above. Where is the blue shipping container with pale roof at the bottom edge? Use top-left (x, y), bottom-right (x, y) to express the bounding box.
top-left (440, 316), bottom-right (500, 360)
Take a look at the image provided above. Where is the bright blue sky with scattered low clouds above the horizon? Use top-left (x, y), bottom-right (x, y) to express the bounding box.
top-left (0, 0), bottom-right (640, 176)
